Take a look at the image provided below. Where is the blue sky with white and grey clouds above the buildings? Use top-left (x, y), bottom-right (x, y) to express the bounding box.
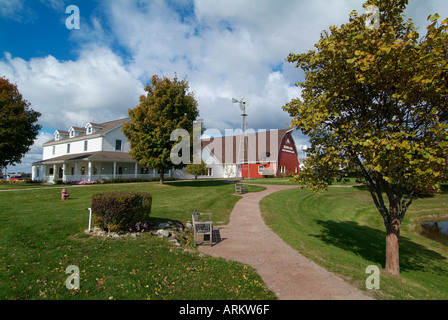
top-left (0, 0), bottom-right (448, 172)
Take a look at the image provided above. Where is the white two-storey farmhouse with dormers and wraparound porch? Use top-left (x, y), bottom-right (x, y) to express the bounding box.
top-left (32, 118), bottom-right (172, 182)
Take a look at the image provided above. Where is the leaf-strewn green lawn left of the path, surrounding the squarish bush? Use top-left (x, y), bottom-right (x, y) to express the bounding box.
top-left (0, 181), bottom-right (275, 300)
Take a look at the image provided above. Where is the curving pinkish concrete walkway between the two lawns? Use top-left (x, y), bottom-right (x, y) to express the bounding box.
top-left (199, 185), bottom-right (372, 300)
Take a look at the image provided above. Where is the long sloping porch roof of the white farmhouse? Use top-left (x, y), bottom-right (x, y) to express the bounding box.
top-left (33, 151), bottom-right (135, 165)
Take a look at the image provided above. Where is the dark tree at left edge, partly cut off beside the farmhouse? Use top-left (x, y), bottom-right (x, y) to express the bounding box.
top-left (0, 77), bottom-right (41, 168)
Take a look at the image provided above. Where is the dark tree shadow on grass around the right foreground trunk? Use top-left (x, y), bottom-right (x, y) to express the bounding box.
top-left (311, 220), bottom-right (448, 273)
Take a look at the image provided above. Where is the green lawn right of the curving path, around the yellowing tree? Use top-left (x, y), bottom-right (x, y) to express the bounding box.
top-left (260, 188), bottom-right (448, 299)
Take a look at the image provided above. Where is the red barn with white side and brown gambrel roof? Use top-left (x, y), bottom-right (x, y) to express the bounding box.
top-left (202, 129), bottom-right (299, 178)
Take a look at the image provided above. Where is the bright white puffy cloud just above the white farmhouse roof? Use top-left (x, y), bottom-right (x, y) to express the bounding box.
top-left (0, 46), bottom-right (143, 130)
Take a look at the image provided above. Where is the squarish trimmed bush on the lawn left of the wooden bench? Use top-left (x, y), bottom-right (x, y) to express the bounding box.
top-left (92, 191), bottom-right (152, 231)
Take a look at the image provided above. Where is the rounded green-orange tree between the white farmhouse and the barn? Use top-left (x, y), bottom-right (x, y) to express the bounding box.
top-left (123, 75), bottom-right (199, 184)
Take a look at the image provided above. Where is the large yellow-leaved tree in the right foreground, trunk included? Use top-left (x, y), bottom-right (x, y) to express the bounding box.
top-left (283, 0), bottom-right (448, 275)
